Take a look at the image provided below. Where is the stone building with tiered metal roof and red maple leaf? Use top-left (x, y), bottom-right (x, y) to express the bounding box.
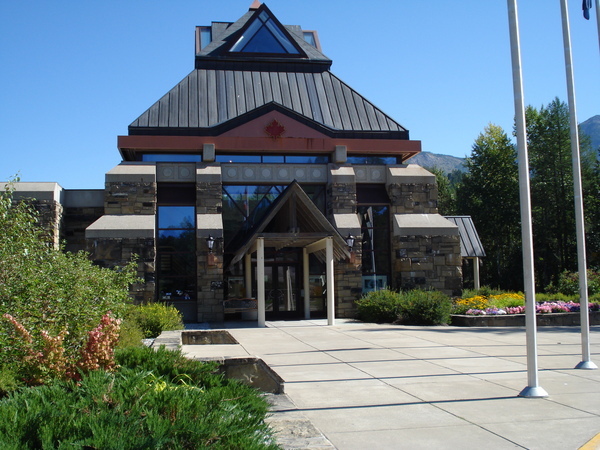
top-left (10, 1), bottom-right (462, 322)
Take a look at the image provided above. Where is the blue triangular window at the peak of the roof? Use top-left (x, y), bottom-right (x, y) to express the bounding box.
top-left (229, 10), bottom-right (300, 55)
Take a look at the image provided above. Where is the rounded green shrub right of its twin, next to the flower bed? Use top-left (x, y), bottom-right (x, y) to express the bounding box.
top-left (399, 289), bottom-right (452, 325)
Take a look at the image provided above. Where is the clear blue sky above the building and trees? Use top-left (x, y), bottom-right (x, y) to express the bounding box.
top-left (0, 0), bottom-right (600, 189)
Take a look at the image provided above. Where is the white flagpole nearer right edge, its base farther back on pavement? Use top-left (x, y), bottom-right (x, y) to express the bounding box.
top-left (560, 0), bottom-right (598, 369)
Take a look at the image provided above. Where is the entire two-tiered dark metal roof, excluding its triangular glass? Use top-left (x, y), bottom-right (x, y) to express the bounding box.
top-left (129, 4), bottom-right (409, 140)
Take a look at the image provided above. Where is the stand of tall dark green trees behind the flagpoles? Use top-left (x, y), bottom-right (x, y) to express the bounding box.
top-left (457, 98), bottom-right (600, 290)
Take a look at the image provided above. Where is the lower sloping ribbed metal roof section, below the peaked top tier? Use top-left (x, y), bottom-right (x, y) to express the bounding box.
top-left (129, 69), bottom-right (408, 139)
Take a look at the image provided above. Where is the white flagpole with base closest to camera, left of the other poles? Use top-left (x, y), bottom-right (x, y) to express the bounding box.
top-left (507, 0), bottom-right (548, 397)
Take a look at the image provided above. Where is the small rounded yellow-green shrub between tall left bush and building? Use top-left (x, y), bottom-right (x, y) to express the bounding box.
top-left (125, 302), bottom-right (183, 338)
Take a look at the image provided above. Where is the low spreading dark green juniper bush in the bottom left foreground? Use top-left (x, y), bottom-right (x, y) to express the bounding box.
top-left (0, 350), bottom-right (277, 449)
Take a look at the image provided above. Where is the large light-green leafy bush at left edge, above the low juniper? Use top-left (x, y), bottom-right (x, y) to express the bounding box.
top-left (0, 184), bottom-right (137, 378)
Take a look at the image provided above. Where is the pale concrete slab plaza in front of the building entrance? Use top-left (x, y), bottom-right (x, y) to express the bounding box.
top-left (183, 319), bottom-right (600, 450)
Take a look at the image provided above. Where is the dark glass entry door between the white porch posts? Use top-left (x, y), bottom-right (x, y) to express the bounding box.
top-left (265, 264), bottom-right (303, 318)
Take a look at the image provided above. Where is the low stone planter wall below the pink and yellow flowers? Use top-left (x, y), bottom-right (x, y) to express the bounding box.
top-left (450, 311), bottom-right (600, 327)
